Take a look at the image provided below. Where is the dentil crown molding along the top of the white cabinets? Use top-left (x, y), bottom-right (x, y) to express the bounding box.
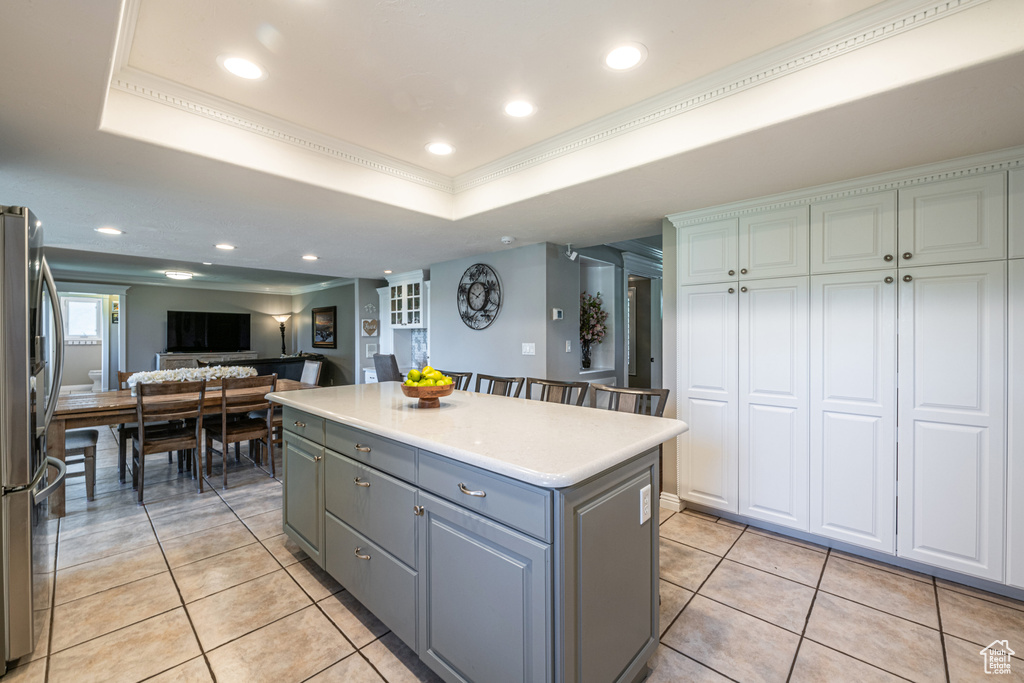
top-left (666, 146), bottom-right (1024, 228)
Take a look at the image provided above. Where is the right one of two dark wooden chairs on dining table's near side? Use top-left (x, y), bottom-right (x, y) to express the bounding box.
top-left (203, 375), bottom-right (278, 488)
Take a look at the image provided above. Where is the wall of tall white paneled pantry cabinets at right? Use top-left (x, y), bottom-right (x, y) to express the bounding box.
top-left (669, 159), bottom-right (1024, 588)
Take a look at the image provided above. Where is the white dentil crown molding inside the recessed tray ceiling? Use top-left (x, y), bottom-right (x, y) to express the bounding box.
top-left (103, 0), bottom-right (988, 205)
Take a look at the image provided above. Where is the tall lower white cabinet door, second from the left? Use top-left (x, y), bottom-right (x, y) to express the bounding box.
top-left (739, 278), bottom-right (809, 530)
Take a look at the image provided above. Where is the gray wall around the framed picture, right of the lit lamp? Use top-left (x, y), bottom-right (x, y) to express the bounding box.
top-left (294, 283), bottom-right (358, 386)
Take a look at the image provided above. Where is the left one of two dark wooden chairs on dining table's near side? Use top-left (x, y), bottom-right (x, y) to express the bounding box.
top-left (131, 380), bottom-right (206, 505)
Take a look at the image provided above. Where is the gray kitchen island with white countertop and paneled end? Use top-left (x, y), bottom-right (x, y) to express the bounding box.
top-left (271, 382), bottom-right (686, 683)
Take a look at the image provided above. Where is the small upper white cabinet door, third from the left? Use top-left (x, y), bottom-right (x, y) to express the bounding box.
top-left (811, 191), bottom-right (896, 273)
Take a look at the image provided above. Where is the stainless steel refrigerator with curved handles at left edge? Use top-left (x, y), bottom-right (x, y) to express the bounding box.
top-left (0, 206), bottom-right (67, 674)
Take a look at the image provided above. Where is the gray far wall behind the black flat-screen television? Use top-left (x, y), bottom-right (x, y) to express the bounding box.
top-left (121, 285), bottom-right (297, 372)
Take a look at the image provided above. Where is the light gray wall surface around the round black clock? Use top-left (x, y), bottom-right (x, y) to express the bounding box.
top-left (430, 244), bottom-right (548, 381)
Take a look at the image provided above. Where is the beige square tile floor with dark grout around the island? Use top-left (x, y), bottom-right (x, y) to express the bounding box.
top-left (4, 431), bottom-right (1024, 683)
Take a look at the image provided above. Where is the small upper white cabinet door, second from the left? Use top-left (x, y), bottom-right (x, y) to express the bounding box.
top-left (739, 206), bottom-right (810, 279)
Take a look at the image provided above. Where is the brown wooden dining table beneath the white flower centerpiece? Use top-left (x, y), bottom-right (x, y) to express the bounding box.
top-left (46, 379), bottom-right (317, 517)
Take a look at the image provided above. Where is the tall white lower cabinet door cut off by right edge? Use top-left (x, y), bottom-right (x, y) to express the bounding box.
top-left (1007, 259), bottom-right (1024, 588)
